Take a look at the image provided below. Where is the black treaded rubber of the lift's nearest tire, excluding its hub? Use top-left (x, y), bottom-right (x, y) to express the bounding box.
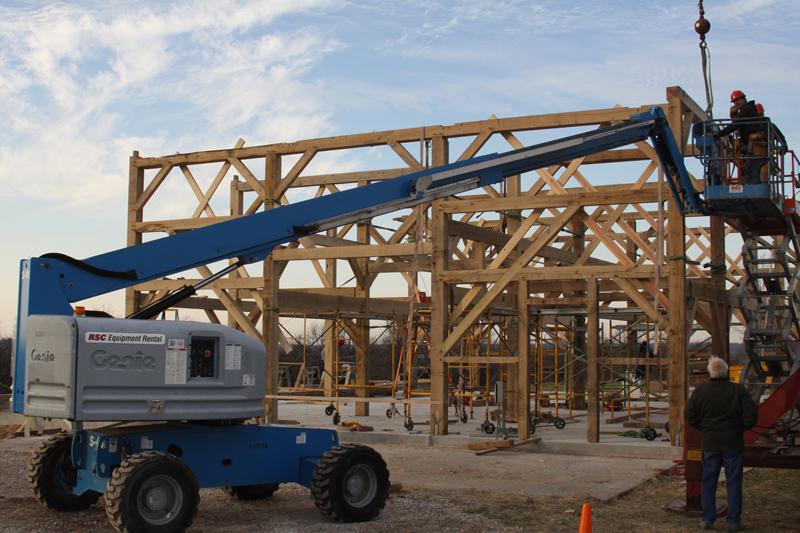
top-left (105, 452), bottom-right (200, 533)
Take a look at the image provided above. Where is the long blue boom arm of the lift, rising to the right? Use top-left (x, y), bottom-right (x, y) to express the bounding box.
top-left (14, 108), bottom-right (701, 412)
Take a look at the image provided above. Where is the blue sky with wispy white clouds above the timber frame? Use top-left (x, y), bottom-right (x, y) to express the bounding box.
top-left (0, 0), bottom-right (800, 335)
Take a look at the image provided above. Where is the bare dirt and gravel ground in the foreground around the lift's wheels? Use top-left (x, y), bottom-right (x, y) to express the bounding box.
top-left (0, 439), bottom-right (800, 533)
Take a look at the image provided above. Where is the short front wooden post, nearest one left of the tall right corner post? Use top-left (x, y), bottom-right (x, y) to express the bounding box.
top-left (586, 278), bottom-right (600, 442)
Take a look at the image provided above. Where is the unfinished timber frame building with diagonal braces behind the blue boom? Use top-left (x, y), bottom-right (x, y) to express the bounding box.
top-left (125, 87), bottom-right (742, 444)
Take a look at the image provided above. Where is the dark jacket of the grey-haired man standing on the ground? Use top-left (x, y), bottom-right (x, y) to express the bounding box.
top-left (686, 378), bottom-right (758, 452)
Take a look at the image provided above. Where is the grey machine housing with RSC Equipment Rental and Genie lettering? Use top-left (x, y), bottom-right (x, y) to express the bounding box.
top-left (24, 315), bottom-right (266, 422)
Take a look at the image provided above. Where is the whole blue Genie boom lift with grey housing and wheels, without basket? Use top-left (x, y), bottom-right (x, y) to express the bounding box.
top-left (13, 108), bottom-right (702, 531)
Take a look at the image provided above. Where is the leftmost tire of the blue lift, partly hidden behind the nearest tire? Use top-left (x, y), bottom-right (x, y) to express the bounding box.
top-left (28, 434), bottom-right (101, 511)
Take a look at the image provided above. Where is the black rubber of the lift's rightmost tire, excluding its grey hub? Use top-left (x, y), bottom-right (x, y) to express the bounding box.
top-left (311, 444), bottom-right (391, 522)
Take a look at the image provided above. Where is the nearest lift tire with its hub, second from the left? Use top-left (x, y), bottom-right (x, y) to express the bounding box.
top-left (106, 452), bottom-right (200, 533)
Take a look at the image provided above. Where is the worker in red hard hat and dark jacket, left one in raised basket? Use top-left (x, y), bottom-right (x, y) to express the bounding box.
top-left (715, 89), bottom-right (766, 185)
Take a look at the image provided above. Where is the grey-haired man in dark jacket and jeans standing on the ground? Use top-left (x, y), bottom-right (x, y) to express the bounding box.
top-left (686, 355), bottom-right (758, 531)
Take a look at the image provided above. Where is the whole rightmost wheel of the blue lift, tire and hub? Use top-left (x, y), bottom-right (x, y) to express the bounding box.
top-left (311, 444), bottom-right (389, 522)
